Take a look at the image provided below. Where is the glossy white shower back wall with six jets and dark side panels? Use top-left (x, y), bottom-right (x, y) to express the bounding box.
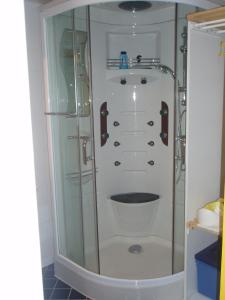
top-left (91, 8), bottom-right (174, 245)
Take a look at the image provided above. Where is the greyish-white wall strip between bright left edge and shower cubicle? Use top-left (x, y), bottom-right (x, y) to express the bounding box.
top-left (25, 1), bottom-right (53, 266)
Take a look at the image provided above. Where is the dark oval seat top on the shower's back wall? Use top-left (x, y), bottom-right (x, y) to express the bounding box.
top-left (110, 193), bottom-right (159, 204)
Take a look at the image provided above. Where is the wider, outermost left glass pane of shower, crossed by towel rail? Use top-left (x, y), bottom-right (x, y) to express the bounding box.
top-left (46, 14), bottom-right (84, 266)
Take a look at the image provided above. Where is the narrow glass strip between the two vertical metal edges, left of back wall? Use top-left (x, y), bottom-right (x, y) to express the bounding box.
top-left (74, 7), bottom-right (99, 272)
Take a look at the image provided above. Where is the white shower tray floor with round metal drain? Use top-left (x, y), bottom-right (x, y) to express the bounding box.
top-left (100, 236), bottom-right (172, 280)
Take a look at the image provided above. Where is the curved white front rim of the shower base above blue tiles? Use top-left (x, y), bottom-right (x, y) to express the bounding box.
top-left (55, 255), bottom-right (184, 300)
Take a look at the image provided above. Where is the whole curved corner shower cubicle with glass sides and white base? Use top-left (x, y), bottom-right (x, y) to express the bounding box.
top-left (42, 1), bottom-right (224, 300)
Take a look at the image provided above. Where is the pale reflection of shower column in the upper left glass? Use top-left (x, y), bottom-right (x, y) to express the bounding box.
top-left (60, 16), bottom-right (90, 116)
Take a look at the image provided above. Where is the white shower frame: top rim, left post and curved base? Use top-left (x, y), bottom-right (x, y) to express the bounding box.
top-left (41, 0), bottom-right (218, 300)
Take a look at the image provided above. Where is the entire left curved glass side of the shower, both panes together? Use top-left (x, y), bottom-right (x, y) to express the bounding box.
top-left (45, 7), bottom-right (99, 272)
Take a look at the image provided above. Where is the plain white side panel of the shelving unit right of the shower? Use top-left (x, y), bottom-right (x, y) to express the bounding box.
top-left (185, 24), bottom-right (224, 299)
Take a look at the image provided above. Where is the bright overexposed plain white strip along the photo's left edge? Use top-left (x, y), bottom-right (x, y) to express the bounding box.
top-left (0, 0), bottom-right (43, 300)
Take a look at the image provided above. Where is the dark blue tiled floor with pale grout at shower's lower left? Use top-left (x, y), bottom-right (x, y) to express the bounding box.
top-left (42, 264), bottom-right (91, 300)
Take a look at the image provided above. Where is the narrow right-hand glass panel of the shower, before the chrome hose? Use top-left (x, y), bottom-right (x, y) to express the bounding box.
top-left (173, 4), bottom-right (196, 273)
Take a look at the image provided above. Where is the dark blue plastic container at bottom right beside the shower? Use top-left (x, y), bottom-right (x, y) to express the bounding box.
top-left (195, 241), bottom-right (221, 300)
